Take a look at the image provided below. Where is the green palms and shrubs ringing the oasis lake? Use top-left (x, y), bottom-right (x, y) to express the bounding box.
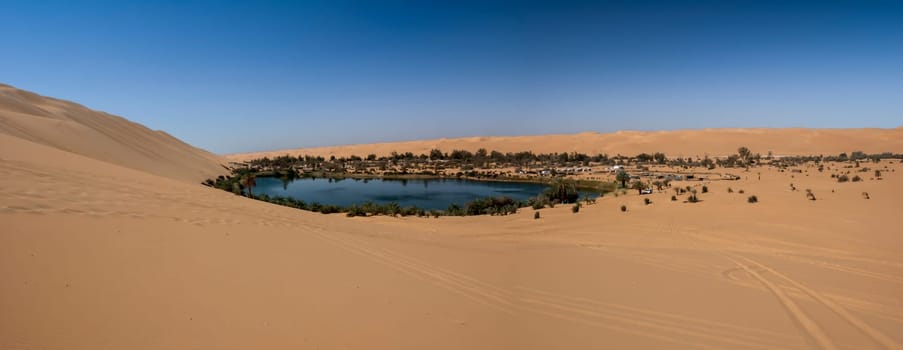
top-left (203, 147), bottom-right (903, 217)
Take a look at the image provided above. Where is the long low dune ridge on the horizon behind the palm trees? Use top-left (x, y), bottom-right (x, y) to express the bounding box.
top-left (227, 127), bottom-right (903, 160)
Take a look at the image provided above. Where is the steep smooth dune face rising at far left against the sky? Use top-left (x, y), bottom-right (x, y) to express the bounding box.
top-left (0, 84), bottom-right (225, 182)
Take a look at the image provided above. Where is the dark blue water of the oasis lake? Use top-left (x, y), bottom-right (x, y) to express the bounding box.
top-left (254, 177), bottom-right (546, 210)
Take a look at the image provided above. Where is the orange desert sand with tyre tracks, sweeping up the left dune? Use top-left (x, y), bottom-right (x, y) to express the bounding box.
top-left (0, 83), bottom-right (903, 349)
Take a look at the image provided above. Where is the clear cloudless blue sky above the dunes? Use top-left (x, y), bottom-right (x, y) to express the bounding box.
top-left (0, 0), bottom-right (903, 153)
